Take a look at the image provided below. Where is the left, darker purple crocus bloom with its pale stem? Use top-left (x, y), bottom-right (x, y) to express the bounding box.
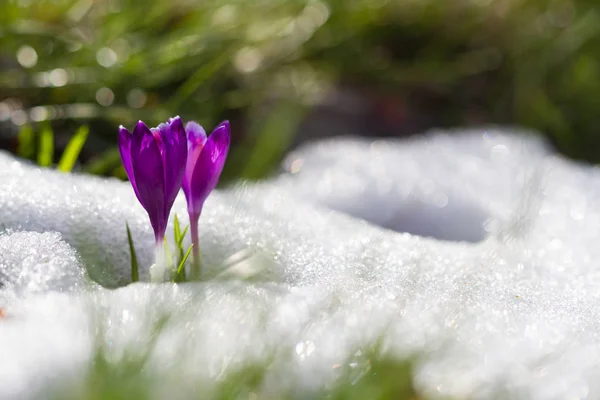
top-left (119, 117), bottom-right (188, 280)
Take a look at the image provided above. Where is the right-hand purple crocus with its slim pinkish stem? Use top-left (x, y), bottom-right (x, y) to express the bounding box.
top-left (182, 121), bottom-right (230, 279)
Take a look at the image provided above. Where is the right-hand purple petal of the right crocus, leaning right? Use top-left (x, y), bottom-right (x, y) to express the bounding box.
top-left (186, 121), bottom-right (230, 214)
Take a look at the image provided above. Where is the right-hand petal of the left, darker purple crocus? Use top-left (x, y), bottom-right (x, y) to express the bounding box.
top-left (155, 117), bottom-right (188, 217)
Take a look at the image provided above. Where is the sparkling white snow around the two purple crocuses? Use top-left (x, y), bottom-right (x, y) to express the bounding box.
top-left (0, 130), bottom-right (600, 399)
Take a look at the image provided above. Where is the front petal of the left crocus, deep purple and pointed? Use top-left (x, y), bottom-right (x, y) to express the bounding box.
top-left (130, 121), bottom-right (168, 240)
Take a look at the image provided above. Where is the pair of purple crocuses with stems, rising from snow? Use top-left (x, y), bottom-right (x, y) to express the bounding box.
top-left (119, 117), bottom-right (230, 281)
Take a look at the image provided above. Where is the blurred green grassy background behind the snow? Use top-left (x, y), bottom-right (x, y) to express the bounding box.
top-left (0, 0), bottom-right (600, 180)
